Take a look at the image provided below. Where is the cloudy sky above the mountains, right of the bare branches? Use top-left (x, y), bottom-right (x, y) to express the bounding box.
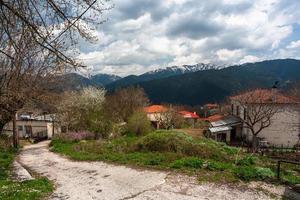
top-left (77, 0), bottom-right (300, 76)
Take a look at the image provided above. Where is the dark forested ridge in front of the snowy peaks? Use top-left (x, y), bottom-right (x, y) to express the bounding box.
top-left (107, 59), bottom-right (300, 105)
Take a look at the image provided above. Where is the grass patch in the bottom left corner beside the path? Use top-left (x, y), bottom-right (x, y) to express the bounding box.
top-left (0, 137), bottom-right (53, 200)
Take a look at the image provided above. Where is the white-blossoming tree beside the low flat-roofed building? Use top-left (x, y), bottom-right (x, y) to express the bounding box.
top-left (57, 87), bottom-right (109, 136)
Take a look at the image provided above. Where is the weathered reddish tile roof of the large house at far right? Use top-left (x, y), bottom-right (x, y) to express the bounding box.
top-left (230, 89), bottom-right (300, 104)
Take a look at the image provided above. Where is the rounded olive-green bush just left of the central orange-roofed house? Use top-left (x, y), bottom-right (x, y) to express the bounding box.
top-left (128, 111), bottom-right (152, 136)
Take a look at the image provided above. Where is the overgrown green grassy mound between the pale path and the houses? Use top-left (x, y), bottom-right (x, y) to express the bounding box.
top-left (51, 131), bottom-right (300, 185)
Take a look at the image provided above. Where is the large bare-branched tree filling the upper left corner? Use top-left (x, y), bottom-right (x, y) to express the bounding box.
top-left (0, 0), bottom-right (111, 147)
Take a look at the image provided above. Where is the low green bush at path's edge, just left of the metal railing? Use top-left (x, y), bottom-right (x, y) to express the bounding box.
top-left (234, 166), bottom-right (275, 181)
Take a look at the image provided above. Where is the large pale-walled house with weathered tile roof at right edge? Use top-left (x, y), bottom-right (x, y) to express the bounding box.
top-left (230, 88), bottom-right (300, 147)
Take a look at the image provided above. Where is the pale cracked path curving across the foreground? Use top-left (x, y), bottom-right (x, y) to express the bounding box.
top-left (18, 142), bottom-right (282, 200)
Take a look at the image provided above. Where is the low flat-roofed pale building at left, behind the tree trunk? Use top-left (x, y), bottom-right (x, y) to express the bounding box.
top-left (4, 114), bottom-right (60, 139)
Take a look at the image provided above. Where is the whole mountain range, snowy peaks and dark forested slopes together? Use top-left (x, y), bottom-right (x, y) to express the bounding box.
top-left (58, 59), bottom-right (300, 105)
